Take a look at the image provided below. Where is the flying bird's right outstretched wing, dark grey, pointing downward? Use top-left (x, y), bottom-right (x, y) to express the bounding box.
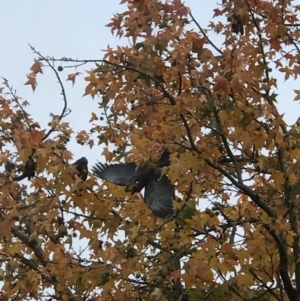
top-left (144, 175), bottom-right (174, 218)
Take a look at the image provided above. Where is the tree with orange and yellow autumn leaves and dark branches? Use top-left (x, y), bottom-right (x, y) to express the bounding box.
top-left (0, 0), bottom-right (300, 301)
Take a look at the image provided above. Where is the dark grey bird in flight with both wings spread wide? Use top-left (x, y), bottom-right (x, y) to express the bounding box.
top-left (92, 151), bottom-right (175, 218)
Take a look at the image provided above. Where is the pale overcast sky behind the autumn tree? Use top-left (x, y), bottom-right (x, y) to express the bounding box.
top-left (0, 0), bottom-right (299, 166)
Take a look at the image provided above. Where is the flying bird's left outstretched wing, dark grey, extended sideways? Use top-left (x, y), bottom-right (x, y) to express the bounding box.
top-left (92, 163), bottom-right (137, 186)
